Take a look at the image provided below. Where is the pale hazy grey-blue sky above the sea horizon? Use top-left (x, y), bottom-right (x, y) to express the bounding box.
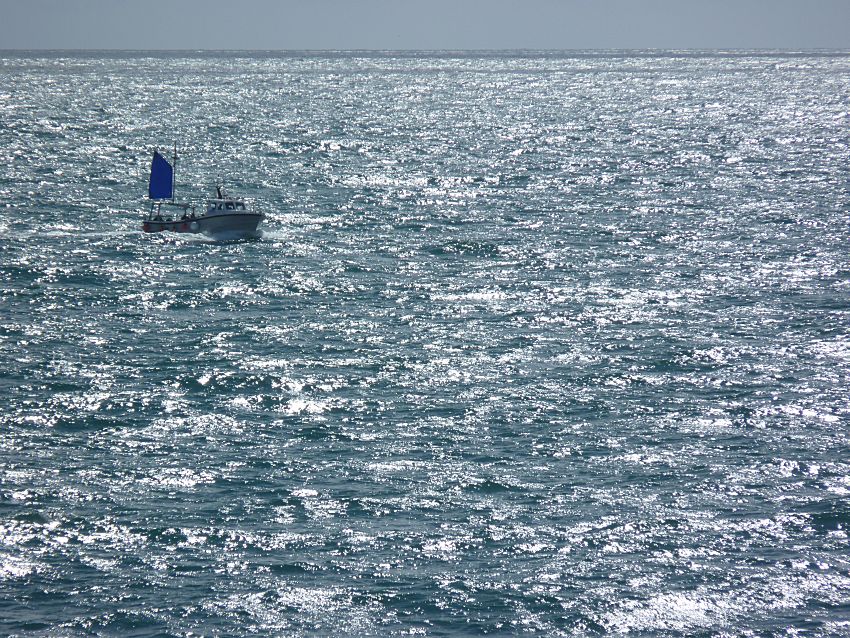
top-left (0, 0), bottom-right (850, 49)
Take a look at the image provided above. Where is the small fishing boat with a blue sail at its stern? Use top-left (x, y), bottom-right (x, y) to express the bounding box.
top-left (142, 146), bottom-right (265, 239)
